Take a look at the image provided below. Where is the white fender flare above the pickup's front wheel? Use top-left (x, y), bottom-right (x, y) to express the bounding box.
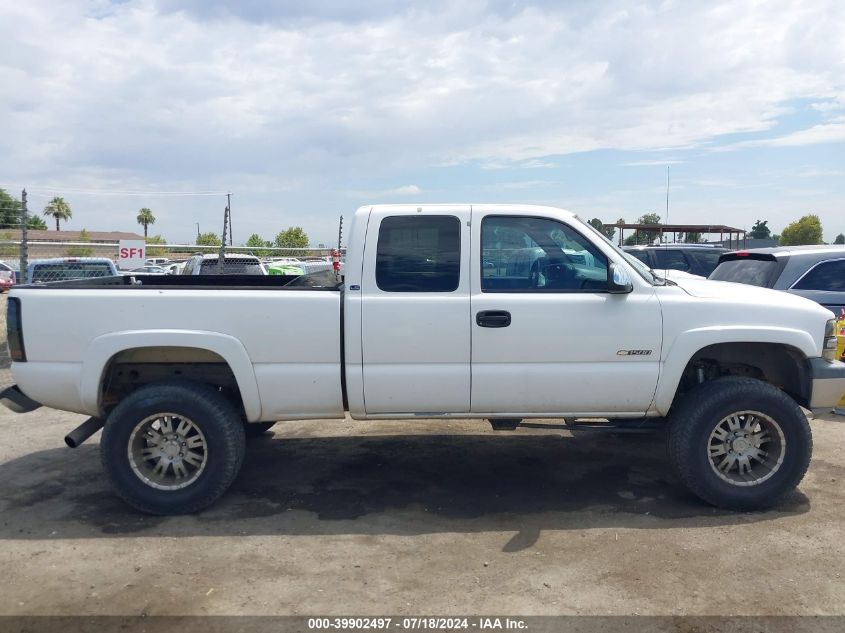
top-left (654, 325), bottom-right (818, 415)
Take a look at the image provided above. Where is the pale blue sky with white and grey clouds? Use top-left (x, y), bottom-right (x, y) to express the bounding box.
top-left (0, 0), bottom-right (845, 243)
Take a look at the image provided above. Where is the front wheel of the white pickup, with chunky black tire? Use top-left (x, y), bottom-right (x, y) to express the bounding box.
top-left (669, 377), bottom-right (813, 510)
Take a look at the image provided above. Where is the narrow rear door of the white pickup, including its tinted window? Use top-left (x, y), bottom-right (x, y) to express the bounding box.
top-left (361, 205), bottom-right (470, 414)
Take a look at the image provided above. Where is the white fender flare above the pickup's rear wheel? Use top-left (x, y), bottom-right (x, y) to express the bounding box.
top-left (79, 330), bottom-right (261, 422)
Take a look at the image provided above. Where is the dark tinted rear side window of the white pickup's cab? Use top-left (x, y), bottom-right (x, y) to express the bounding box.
top-left (376, 215), bottom-right (461, 292)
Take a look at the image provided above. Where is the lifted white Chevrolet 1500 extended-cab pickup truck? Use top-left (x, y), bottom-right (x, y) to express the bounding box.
top-left (2, 204), bottom-right (845, 514)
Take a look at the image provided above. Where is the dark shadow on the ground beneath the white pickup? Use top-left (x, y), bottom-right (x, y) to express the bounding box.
top-left (0, 433), bottom-right (810, 550)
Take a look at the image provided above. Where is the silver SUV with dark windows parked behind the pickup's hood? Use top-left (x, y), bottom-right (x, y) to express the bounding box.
top-left (709, 244), bottom-right (845, 316)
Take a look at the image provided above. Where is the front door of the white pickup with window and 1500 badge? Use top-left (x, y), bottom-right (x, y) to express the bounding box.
top-left (471, 206), bottom-right (662, 417)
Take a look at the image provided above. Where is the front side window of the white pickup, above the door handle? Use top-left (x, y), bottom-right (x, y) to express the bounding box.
top-left (481, 215), bottom-right (607, 292)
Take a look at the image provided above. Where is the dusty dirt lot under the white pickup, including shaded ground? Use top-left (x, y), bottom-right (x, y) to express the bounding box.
top-left (0, 292), bottom-right (845, 615)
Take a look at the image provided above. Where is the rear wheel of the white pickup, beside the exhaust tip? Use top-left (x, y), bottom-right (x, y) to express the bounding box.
top-left (100, 382), bottom-right (245, 514)
